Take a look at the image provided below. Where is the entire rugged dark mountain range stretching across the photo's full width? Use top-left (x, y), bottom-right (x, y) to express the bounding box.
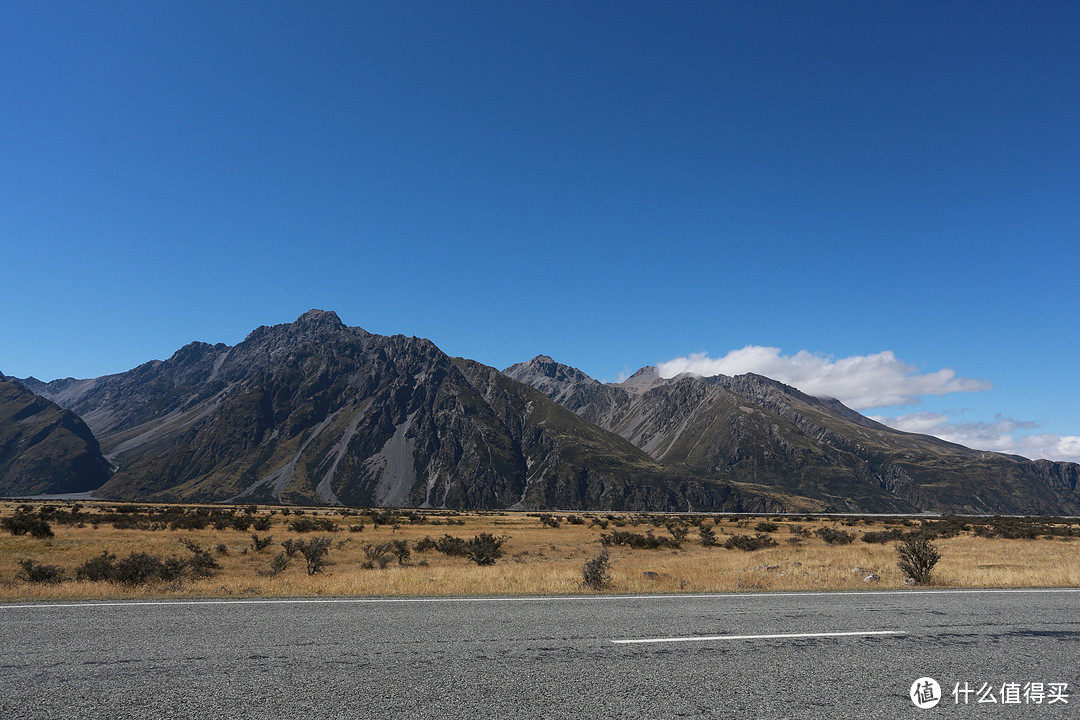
top-left (0, 310), bottom-right (1080, 514)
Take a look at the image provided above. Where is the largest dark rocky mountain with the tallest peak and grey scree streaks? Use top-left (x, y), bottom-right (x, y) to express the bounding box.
top-left (25, 311), bottom-right (760, 511)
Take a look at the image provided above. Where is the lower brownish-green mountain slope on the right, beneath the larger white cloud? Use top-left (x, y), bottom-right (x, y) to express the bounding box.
top-left (504, 355), bottom-right (1080, 514)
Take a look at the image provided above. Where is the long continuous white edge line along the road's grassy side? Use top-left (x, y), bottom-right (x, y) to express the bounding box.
top-left (0, 587), bottom-right (1080, 610)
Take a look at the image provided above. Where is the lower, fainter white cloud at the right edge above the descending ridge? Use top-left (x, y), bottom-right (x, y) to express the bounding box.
top-left (872, 412), bottom-right (1080, 462)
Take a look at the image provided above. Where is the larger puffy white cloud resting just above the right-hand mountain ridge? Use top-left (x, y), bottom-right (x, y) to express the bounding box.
top-left (657, 345), bottom-right (991, 410)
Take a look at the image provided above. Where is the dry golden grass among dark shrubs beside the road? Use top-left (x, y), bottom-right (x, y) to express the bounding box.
top-left (0, 503), bottom-right (1080, 600)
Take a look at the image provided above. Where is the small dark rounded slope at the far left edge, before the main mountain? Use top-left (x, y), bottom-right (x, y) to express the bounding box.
top-left (0, 376), bottom-right (111, 497)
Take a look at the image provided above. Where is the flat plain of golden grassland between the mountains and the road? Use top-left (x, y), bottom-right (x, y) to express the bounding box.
top-left (0, 502), bottom-right (1080, 601)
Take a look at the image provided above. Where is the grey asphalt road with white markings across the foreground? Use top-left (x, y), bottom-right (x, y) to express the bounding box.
top-left (0, 589), bottom-right (1080, 720)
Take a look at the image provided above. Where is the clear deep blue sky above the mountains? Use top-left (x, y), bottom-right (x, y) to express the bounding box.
top-left (0, 1), bottom-right (1080, 460)
